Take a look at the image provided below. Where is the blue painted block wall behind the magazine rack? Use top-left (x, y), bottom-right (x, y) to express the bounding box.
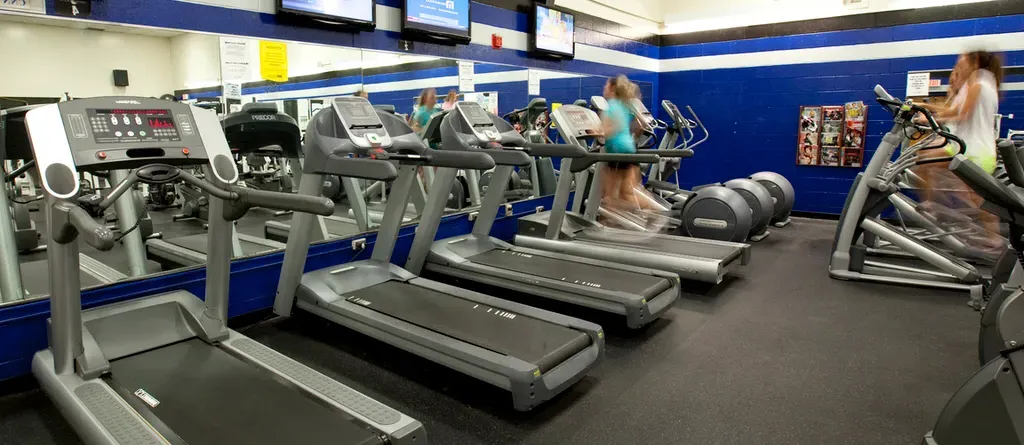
top-left (658, 15), bottom-right (1024, 214)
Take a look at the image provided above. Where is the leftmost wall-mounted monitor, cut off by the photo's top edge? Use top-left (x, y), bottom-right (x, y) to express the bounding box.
top-left (278, 0), bottom-right (377, 30)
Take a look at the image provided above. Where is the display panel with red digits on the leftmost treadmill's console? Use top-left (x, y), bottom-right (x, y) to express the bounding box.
top-left (87, 108), bottom-right (181, 143)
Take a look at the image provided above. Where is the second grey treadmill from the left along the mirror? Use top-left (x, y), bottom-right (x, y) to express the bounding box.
top-left (274, 97), bottom-right (604, 411)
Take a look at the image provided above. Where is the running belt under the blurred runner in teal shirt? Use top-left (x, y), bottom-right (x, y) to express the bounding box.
top-left (577, 228), bottom-right (742, 261)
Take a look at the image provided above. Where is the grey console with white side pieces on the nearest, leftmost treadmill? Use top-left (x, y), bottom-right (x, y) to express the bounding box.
top-left (26, 97), bottom-right (239, 198)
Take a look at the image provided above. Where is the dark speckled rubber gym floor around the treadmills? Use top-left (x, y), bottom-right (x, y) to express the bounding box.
top-left (0, 219), bottom-right (978, 445)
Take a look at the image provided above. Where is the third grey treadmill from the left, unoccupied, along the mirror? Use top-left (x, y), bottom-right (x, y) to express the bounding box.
top-left (406, 102), bottom-right (679, 328)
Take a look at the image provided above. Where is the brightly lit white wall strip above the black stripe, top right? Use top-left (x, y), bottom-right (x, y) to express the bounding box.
top-left (663, 0), bottom-right (992, 34)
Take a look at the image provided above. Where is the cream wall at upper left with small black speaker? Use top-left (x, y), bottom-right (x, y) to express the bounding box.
top-left (0, 21), bottom-right (173, 97)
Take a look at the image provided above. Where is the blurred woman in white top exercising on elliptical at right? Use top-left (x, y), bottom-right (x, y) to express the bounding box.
top-left (919, 51), bottom-right (1006, 252)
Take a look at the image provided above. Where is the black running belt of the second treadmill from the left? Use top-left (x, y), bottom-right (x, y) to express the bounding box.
top-left (344, 280), bottom-right (590, 372)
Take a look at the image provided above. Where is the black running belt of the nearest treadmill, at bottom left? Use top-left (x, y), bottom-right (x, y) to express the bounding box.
top-left (109, 339), bottom-right (382, 445)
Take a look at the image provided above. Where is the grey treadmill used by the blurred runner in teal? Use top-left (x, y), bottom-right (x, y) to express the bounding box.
top-left (515, 105), bottom-right (751, 284)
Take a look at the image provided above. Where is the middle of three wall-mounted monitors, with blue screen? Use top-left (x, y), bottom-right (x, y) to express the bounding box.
top-left (401, 0), bottom-right (472, 43)
